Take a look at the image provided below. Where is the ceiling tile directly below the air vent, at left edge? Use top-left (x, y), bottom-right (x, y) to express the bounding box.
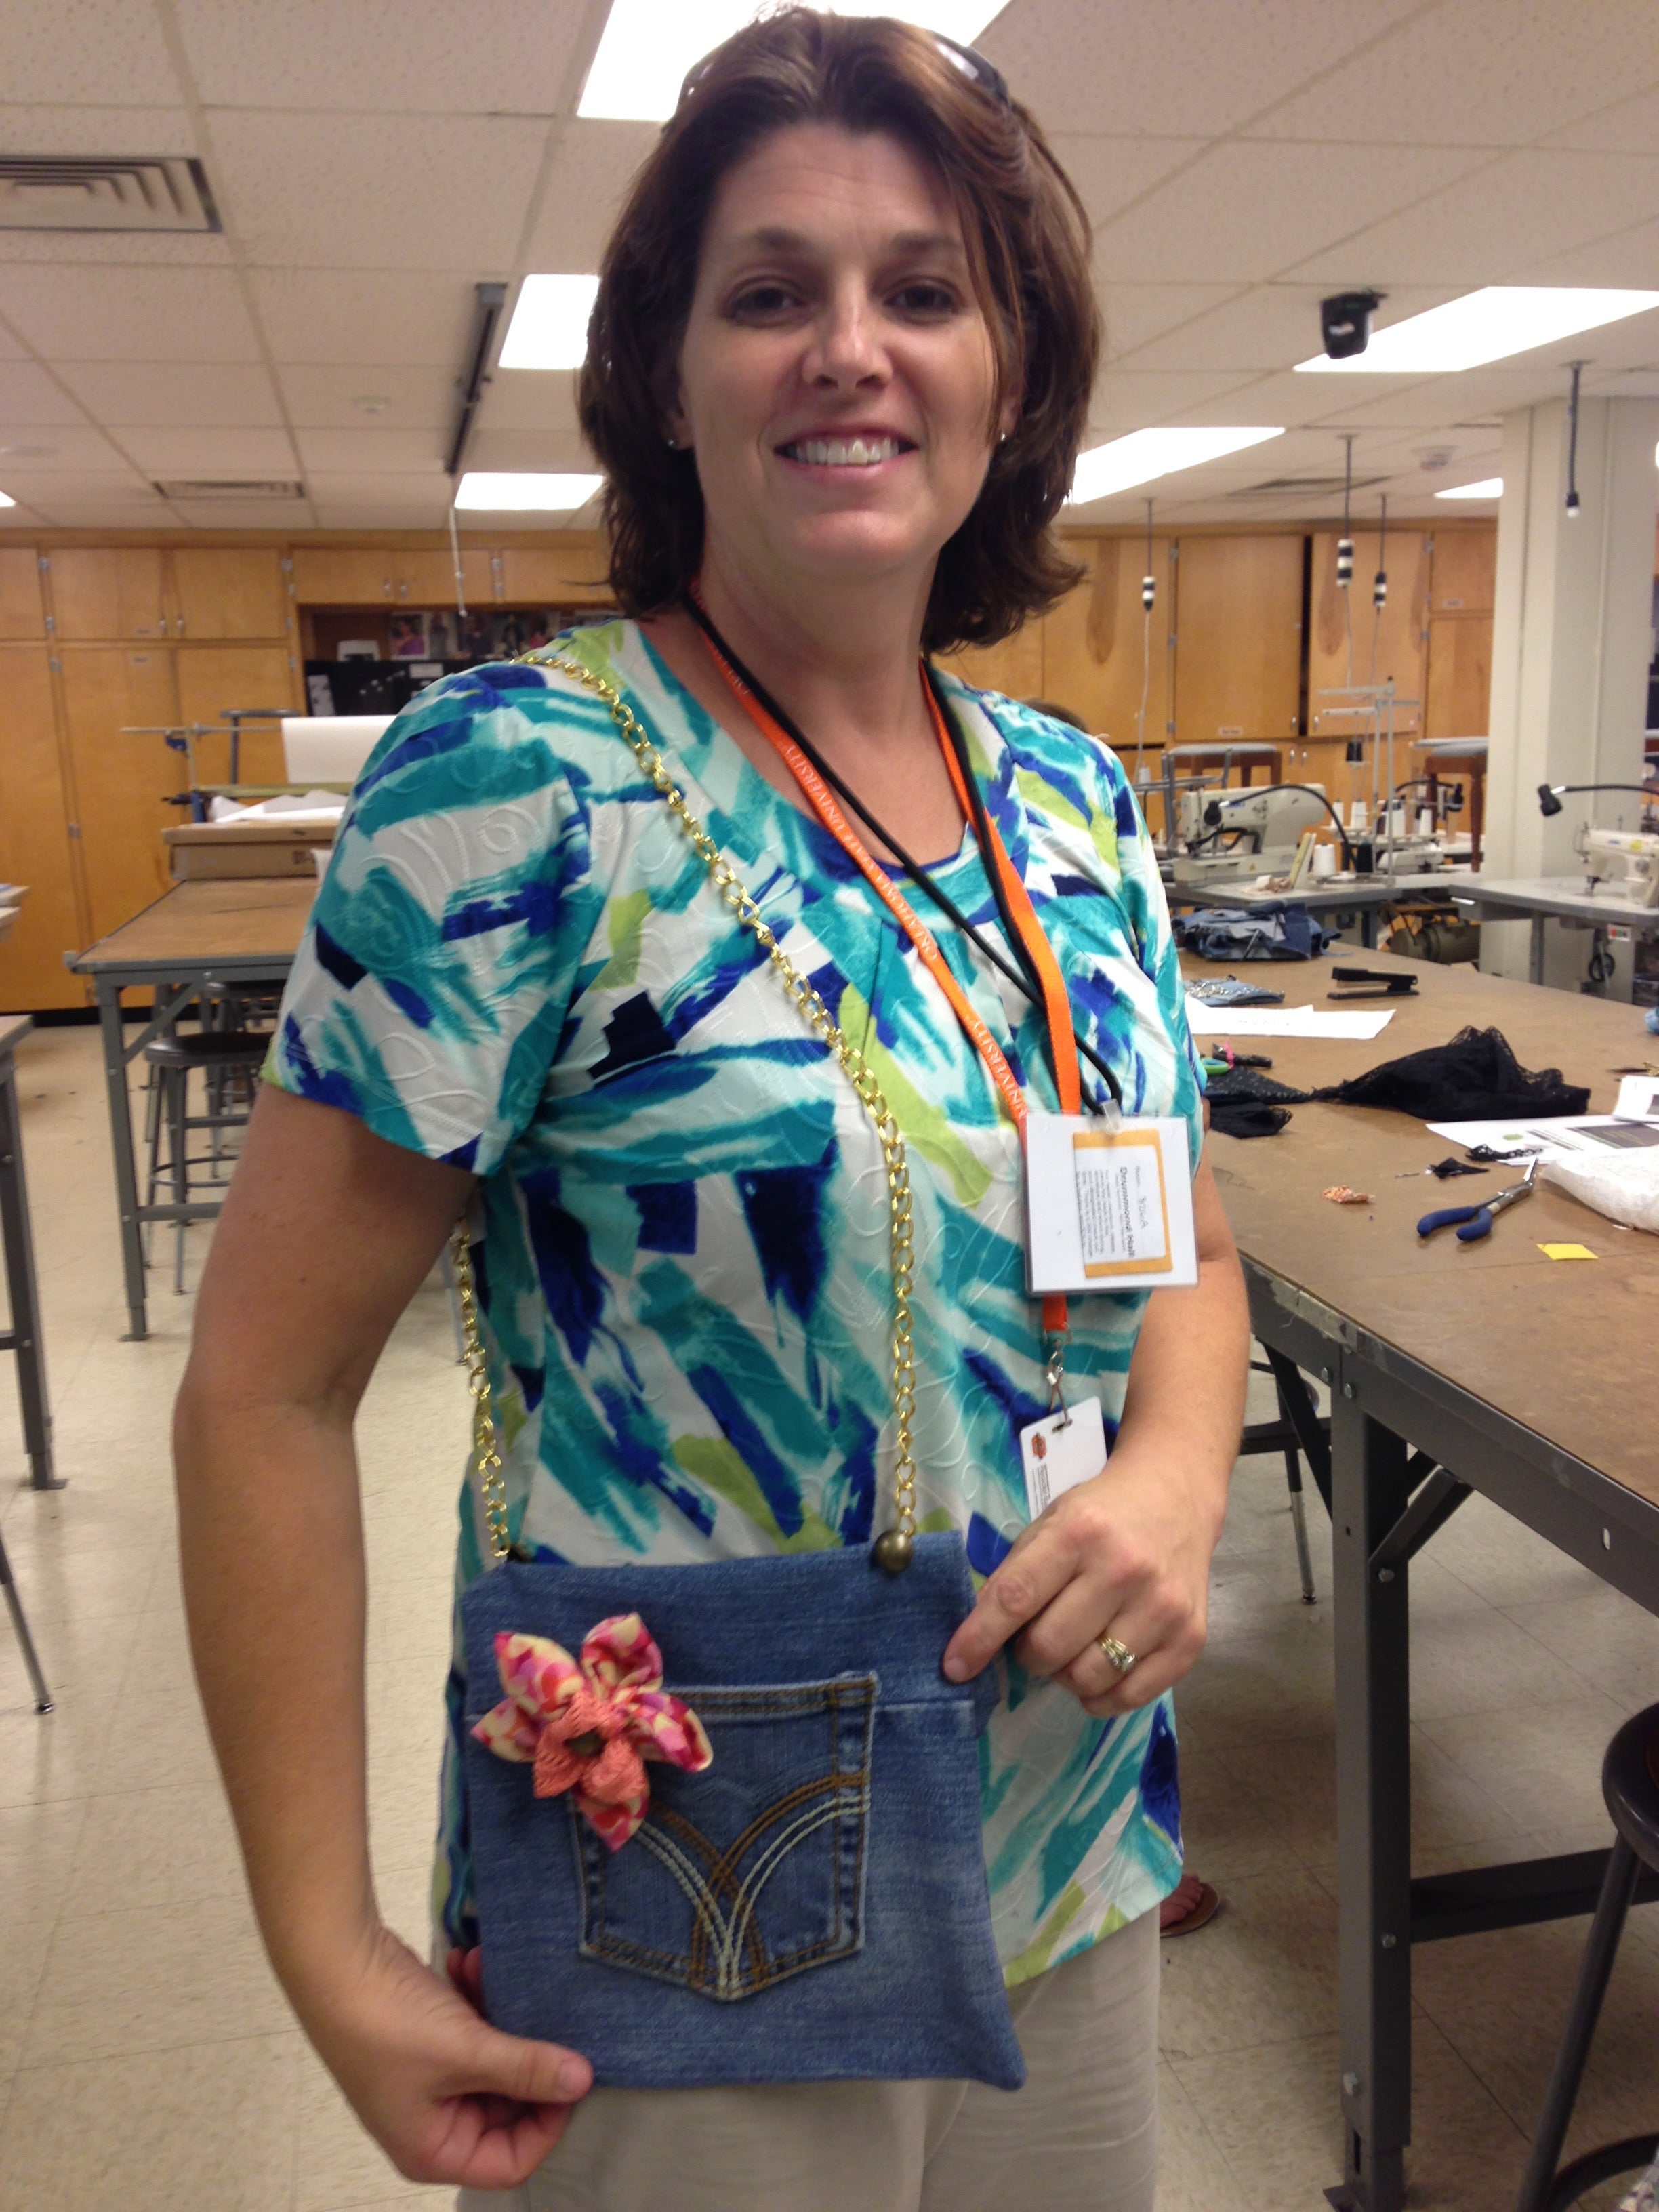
top-left (0, 266), bottom-right (259, 361)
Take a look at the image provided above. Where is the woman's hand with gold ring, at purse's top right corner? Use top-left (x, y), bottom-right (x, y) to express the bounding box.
top-left (945, 1442), bottom-right (1221, 1717)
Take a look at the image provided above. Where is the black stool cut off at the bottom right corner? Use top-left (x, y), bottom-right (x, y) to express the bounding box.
top-left (1515, 1706), bottom-right (1659, 2212)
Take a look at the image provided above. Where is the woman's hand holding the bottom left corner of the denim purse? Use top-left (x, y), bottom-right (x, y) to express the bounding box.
top-left (301, 1929), bottom-right (593, 2190)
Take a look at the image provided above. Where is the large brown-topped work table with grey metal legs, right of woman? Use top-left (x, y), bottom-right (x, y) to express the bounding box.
top-left (1183, 954), bottom-right (1659, 2212)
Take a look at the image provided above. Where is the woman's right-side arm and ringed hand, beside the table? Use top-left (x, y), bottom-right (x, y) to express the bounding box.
top-left (945, 1162), bottom-right (1250, 1715)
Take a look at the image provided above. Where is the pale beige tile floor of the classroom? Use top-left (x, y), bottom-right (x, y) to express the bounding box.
top-left (0, 1029), bottom-right (1659, 2212)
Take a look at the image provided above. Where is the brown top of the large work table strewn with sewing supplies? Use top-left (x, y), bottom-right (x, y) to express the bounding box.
top-left (1181, 954), bottom-right (1659, 1504)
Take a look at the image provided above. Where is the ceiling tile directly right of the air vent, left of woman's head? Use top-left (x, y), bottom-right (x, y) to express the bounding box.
top-left (212, 110), bottom-right (546, 276)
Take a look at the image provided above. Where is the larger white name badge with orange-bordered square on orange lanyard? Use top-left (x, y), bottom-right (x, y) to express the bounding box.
top-left (1026, 1113), bottom-right (1199, 1298)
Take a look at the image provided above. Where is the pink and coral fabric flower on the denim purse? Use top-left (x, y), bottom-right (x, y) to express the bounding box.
top-left (473, 1612), bottom-right (714, 1851)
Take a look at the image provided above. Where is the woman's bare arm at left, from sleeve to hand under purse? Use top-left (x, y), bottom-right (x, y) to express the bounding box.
top-left (175, 1086), bottom-right (590, 2190)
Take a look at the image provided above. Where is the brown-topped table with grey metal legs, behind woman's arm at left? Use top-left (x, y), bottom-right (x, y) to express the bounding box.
top-left (68, 876), bottom-right (316, 1340)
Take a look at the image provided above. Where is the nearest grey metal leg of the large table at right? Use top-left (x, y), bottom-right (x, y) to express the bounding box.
top-left (1327, 1385), bottom-right (1411, 2212)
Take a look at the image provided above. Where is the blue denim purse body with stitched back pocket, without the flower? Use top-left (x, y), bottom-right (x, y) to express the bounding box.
top-left (462, 1535), bottom-right (1024, 2088)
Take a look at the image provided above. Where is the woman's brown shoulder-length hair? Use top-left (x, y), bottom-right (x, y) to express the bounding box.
top-left (579, 7), bottom-right (1099, 653)
